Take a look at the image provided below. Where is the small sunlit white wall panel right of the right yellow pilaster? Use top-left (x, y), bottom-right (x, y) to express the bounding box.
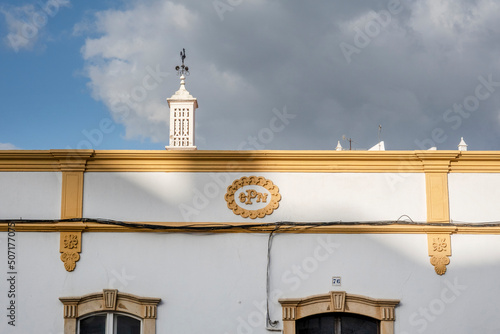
top-left (448, 173), bottom-right (500, 223)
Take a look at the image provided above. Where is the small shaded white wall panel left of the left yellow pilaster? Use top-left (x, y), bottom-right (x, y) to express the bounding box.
top-left (0, 172), bottom-right (62, 219)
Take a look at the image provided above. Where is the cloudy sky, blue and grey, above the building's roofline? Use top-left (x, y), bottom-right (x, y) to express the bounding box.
top-left (0, 0), bottom-right (500, 150)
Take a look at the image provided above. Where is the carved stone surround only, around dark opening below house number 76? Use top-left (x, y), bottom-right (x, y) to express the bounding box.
top-left (279, 291), bottom-right (399, 334)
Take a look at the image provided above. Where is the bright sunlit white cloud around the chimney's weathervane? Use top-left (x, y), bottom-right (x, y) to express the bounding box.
top-left (78, 1), bottom-right (260, 143)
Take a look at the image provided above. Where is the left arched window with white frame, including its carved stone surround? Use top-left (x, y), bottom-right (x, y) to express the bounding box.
top-left (59, 290), bottom-right (160, 334)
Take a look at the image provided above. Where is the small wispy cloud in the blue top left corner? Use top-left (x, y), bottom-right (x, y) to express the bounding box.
top-left (0, 0), bottom-right (70, 52)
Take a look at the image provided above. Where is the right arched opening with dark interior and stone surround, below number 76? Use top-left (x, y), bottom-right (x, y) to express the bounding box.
top-left (279, 291), bottom-right (399, 334)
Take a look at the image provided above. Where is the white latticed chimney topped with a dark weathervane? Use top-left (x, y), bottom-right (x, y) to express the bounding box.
top-left (165, 49), bottom-right (198, 150)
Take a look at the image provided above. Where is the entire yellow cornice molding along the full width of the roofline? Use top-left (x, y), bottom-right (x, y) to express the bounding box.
top-left (0, 150), bottom-right (500, 173)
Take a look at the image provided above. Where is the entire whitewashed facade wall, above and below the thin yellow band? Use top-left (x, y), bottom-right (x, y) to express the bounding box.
top-left (0, 173), bottom-right (500, 334)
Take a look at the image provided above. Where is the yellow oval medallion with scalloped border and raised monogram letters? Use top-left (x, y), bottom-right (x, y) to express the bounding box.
top-left (224, 176), bottom-right (281, 219)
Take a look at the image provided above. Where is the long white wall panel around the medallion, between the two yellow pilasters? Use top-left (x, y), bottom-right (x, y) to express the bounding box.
top-left (83, 173), bottom-right (426, 222)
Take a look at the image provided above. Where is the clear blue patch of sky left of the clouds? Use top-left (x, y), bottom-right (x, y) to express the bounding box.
top-left (0, 1), bottom-right (137, 149)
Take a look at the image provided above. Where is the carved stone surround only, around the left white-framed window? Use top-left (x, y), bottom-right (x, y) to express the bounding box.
top-left (59, 289), bottom-right (161, 334)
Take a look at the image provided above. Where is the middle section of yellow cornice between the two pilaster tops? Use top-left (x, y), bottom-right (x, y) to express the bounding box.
top-left (87, 150), bottom-right (423, 173)
